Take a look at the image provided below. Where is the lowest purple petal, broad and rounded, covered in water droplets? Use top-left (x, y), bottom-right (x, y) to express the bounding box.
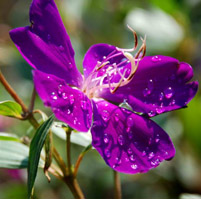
top-left (91, 100), bottom-right (175, 174)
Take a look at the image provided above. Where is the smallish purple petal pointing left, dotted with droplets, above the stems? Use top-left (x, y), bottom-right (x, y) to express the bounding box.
top-left (33, 70), bottom-right (92, 132)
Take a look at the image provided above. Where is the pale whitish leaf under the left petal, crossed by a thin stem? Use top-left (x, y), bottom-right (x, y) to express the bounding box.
top-left (52, 122), bottom-right (92, 147)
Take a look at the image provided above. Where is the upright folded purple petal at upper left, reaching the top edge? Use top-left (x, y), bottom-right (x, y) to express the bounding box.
top-left (10, 0), bottom-right (82, 87)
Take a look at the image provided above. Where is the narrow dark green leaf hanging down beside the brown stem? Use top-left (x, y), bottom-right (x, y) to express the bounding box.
top-left (28, 115), bottom-right (54, 198)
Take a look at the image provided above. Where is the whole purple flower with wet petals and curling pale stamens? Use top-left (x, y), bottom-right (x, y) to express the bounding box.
top-left (10, 0), bottom-right (198, 174)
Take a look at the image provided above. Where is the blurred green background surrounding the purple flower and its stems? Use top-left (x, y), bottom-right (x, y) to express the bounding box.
top-left (0, 0), bottom-right (201, 199)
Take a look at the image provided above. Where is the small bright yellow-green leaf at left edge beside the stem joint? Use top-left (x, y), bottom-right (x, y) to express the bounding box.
top-left (0, 101), bottom-right (22, 118)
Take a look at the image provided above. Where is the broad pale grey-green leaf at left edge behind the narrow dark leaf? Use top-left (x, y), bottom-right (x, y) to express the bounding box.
top-left (0, 139), bottom-right (29, 169)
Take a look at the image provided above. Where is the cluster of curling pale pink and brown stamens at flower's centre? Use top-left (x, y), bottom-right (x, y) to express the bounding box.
top-left (82, 26), bottom-right (146, 98)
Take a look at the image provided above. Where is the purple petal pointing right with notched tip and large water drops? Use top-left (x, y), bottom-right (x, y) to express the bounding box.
top-left (100, 55), bottom-right (198, 117)
